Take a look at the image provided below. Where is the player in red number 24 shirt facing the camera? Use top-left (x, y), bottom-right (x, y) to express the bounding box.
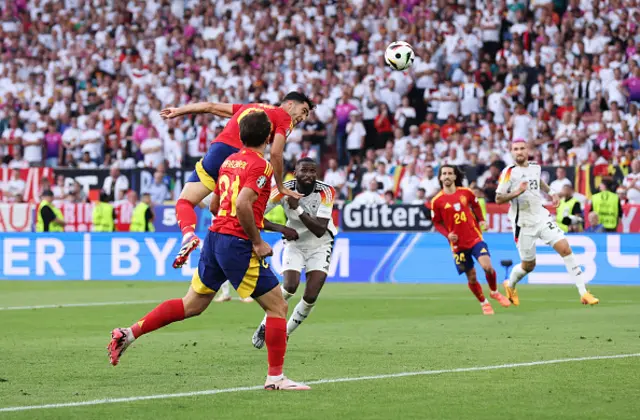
top-left (431, 165), bottom-right (511, 315)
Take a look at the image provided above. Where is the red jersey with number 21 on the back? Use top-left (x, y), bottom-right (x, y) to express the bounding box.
top-left (209, 149), bottom-right (273, 239)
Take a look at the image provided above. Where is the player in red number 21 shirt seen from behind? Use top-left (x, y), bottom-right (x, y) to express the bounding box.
top-left (107, 111), bottom-right (309, 390)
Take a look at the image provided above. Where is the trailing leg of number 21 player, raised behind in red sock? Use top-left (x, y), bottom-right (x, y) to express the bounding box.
top-left (107, 286), bottom-right (215, 366)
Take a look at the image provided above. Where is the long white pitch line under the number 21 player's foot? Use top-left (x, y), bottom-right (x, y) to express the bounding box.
top-left (0, 353), bottom-right (640, 413)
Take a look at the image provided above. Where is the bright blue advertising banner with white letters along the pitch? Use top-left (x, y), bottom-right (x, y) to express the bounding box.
top-left (0, 232), bottom-right (640, 285)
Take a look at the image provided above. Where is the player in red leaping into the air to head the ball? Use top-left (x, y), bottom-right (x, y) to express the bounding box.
top-left (160, 92), bottom-right (313, 268)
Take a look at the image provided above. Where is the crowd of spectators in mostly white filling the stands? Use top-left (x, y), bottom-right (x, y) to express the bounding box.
top-left (0, 0), bottom-right (640, 203)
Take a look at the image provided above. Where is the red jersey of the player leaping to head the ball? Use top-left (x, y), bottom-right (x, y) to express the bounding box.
top-left (212, 104), bottom-right (293, 149)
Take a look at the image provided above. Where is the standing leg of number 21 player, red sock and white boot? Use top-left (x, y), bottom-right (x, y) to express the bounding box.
top-left (256, 287), bottom-right (311, 391)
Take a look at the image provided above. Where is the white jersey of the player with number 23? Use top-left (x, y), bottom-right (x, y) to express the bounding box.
top-left (496, 163), bottom-right (550, 227)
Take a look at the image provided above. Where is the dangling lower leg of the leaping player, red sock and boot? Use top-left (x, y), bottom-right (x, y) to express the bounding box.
top-left (173, 182), bottom-right (211, 268)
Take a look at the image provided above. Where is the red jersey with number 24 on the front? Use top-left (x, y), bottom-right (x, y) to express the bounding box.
top-left (431, 187), bottom-right (484, 251)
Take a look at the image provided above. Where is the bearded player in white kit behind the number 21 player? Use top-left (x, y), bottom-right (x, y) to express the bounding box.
top-left (252, 158), bottom-right (338, 349)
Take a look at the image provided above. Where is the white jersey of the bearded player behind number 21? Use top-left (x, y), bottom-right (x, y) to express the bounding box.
top-left (265, 179), bottom-right (338, 249)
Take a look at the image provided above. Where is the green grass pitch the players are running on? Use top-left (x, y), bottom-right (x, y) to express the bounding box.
top-left (0, 282), bottom-right (640, 420)
